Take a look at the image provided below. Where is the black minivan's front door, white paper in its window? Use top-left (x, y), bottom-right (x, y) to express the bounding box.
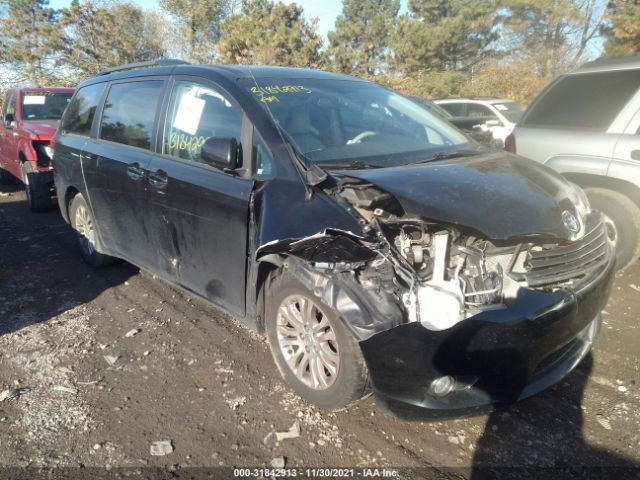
top-left (148, 77), bottom-right (253, 315)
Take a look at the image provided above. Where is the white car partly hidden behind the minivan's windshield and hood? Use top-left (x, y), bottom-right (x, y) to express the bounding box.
top-left (435, 97), bottom-right (523, 145)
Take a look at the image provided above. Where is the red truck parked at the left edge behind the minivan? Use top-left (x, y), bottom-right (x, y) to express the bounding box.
top-left (0, 87), bottom-right (74, 212)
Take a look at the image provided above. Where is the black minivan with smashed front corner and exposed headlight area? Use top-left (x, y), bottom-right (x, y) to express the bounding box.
top-left (54, 61), bottom-right (614, 410)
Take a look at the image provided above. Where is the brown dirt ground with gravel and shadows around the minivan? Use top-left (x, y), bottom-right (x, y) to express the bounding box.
top-left (0, 187), bottom-right (640, 478)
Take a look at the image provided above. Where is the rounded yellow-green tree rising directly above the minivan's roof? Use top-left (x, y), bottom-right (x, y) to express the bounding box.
top-left (218, 0), bottom-right (322, 67)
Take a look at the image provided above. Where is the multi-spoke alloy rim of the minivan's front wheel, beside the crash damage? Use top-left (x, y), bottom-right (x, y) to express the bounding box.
top-left (277, 295), bottom-right (340, 390)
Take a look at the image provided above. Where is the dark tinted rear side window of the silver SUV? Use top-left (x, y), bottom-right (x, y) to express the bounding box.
top-left (522, 70), bottom-right (640, 132)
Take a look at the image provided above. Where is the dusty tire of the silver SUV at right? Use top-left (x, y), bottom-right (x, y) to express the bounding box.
top-left (585, 188), bottom-right (640, 271)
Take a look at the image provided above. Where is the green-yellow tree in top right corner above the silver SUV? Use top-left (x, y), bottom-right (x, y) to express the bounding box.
top-left (602, 0), bottom-right (640, 56)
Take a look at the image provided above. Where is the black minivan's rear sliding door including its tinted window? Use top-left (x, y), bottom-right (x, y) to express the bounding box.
top-left (82, 77), bottom-right (166, 268)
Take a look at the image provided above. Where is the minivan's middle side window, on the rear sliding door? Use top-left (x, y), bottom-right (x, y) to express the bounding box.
top-left (100, 80), bottom-right (163, 150)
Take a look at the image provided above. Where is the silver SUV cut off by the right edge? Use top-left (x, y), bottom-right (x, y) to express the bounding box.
top-left (506, 56), bottom-right (640, 269)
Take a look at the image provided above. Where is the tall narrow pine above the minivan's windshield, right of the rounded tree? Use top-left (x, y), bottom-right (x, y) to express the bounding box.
top-left (323, 0), bottom-right (400, 75)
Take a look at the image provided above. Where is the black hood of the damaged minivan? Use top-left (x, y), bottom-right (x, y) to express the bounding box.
top-left (331, 152), bottom-right (579, 241)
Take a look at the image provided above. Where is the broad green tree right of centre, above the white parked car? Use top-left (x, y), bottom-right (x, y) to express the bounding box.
top-left (392, 0), bottom-right (499, 72)
